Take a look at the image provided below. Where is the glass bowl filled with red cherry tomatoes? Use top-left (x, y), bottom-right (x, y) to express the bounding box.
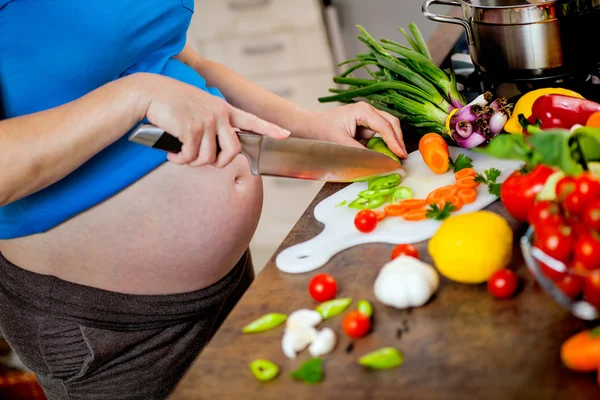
top-left (520, 172), bottom-right (600, 320)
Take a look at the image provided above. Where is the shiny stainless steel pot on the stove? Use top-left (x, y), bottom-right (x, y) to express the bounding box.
top-left (422, 0), bottom-right (600, 79)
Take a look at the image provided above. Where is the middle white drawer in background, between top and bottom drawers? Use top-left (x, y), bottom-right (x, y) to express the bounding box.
top-left (203, 29), bottom-right (333, 78)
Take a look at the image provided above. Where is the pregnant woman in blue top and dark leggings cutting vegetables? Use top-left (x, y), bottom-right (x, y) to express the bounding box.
top-left (0, 0), bottom-right (406, 400)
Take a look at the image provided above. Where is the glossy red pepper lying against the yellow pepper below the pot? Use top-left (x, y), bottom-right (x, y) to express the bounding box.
top-left (528, 94), bottom-right (600, 130)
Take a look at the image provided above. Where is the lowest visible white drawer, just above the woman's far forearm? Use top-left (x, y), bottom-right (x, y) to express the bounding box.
top-left (255, 70), bottom-right (338, 111)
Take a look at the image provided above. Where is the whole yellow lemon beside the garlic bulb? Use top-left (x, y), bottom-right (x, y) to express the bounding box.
top-left (429, 211), bottom-right (513, 284)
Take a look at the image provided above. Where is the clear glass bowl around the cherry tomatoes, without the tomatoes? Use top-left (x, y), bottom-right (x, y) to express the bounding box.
top-left (520, 226), bottom-right (600, 321)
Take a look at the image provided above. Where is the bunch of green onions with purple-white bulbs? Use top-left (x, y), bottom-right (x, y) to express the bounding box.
top-left (319, 23), bottom-right (513, 148)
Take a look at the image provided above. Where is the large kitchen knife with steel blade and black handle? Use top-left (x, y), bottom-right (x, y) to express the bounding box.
top-left (129, 124), bottom-right (402, 182)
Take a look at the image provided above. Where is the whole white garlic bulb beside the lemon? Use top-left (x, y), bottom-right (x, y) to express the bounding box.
top-left (373, 255), bottom-right (439, 309)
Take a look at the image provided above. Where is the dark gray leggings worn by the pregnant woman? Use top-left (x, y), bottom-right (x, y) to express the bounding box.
top-left (0, 253), bottom-right (254, 400)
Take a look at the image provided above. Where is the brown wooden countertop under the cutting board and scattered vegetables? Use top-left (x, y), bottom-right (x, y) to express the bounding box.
top-left (171, 17), bottom-right (600, 400)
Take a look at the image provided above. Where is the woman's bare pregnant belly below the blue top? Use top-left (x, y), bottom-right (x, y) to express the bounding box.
top-left (0, 155), bottom-right (262, 294)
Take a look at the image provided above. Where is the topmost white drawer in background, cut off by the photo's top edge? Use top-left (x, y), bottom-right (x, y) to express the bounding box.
top-left (190, 0), bottom-right (323, 39)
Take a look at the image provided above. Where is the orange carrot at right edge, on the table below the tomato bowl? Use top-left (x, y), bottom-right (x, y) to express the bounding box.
top-left (560, 328), bottom-right (600, 372)
